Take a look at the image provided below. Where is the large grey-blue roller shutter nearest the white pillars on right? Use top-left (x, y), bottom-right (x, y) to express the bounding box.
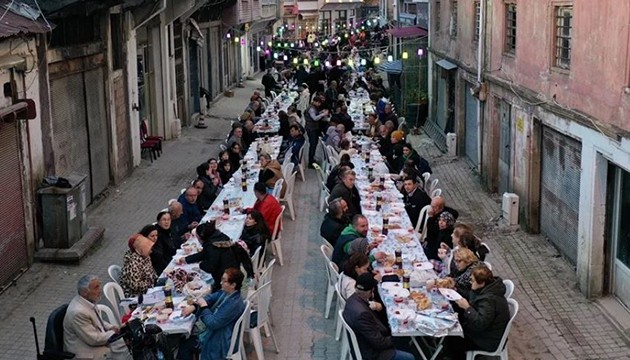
top-left (540, 127), bottom-right (582, 264)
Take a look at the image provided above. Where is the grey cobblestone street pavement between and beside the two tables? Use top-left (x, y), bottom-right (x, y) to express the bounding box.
top-left (0, 75), bottom-right (630, 360)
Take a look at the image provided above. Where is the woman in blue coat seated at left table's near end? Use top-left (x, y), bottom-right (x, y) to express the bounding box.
top-left (178, 268), bottom-right (245, 360)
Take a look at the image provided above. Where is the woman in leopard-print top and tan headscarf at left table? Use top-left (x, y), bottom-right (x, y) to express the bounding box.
top-left (118, 230), bottom-right (157, 297)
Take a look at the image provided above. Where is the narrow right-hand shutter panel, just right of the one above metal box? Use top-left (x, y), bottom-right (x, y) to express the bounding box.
top-left (83, 68), bottom-right (110, 197)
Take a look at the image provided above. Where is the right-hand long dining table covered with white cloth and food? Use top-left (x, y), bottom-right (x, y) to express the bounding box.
top-left (351, 142), bottom-right (463, 360)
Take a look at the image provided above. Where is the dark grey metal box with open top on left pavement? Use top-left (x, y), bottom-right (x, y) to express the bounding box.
top-left (37, 174), bottom-right (87, 249)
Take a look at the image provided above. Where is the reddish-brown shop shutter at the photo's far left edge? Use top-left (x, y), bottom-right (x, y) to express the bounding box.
top-left (0, 123), bottom-right (28, 285)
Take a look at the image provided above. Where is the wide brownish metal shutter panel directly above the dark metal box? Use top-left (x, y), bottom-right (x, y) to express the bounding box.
top-left (50, 73), bottom-right (92, 202)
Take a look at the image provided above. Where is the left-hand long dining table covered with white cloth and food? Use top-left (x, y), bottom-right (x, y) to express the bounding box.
top-left (126, 136), bottom-right (282, 336)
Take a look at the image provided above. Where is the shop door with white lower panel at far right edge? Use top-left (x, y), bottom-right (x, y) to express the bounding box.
top-left (607, 166), bottom-right (630, 307)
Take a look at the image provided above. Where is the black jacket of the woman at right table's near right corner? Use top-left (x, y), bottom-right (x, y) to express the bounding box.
top-left (459, 277), bottom-right (510, 351)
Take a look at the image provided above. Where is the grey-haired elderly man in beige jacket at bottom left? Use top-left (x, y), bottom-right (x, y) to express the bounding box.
top-left (63, 275), bottom-right (131, 360)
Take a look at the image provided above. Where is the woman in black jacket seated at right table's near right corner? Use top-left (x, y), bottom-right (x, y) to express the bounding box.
top-left (448, 265), bottom-right (510, 359)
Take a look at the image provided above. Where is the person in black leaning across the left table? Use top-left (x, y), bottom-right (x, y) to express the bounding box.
top-left (177, 221), bottom-right (253, 291)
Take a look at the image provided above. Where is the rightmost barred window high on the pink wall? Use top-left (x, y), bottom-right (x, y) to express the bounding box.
top-left (551, 3), bottom-right (573, 72)
